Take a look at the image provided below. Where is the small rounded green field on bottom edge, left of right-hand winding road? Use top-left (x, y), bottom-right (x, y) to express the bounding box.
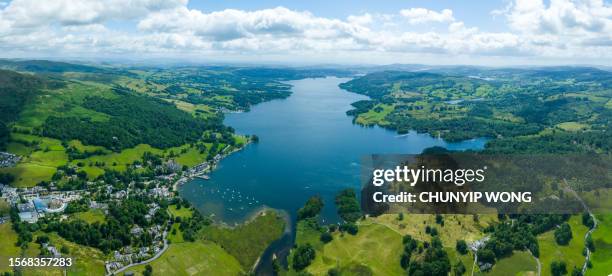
top-left (478, 251), bottom-right (536, 276)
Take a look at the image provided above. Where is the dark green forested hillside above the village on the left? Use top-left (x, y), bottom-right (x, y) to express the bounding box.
top-left (43, 87), bottom-right (230, 150)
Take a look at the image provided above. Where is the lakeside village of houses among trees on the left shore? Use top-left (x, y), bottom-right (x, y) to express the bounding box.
top-left (0, 146), bottom-right (232, 275)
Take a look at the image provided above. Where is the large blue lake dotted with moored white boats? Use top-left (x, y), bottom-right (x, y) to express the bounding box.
top-left (180, 77), bottom-right (486, 271)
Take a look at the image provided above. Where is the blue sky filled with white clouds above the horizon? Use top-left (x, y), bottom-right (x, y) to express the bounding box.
top-left (0, 0), bottom-right (612, 66)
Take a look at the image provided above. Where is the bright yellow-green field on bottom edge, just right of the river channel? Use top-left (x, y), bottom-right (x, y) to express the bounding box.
top-left (307, 224), bottom-right (404, 275)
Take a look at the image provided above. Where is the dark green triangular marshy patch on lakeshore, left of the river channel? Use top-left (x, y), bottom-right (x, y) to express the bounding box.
top-left (201, 211), bottom-right (285, 271)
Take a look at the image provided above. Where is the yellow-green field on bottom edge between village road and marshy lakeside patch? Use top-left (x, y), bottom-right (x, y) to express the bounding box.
top-left (127, 241), bottom-right (244, 275)
